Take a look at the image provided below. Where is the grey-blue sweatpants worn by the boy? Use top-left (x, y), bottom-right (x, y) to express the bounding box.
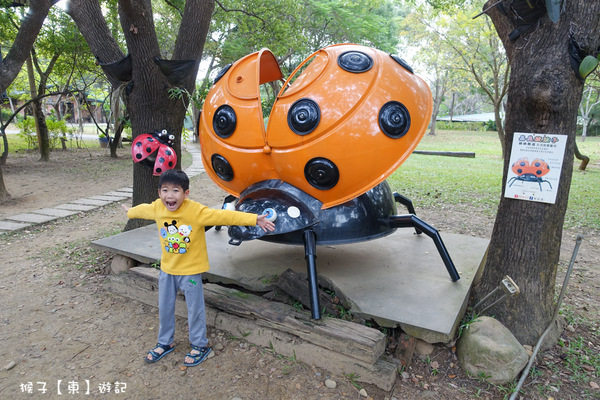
top-left (158, 271), bottom-right (208, 347)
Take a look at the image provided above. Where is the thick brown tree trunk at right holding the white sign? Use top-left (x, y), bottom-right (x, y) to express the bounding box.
top-left (473, 0), bottom-right (600, 345)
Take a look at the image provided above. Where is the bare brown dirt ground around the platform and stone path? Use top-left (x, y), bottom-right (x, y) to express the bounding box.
top-left (0, 149), bottom-right (600, 400)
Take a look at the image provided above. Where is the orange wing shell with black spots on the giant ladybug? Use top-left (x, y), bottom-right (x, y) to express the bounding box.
top-left (199, 44), bottom-right (432, 208)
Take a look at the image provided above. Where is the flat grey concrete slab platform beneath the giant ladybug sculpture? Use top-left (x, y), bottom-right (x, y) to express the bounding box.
top-left (93, 225), bottom-right (488, 343)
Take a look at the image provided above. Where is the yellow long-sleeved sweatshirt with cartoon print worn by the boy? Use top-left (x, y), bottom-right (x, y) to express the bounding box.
top-left (127, 199), bottom-right (257, 275)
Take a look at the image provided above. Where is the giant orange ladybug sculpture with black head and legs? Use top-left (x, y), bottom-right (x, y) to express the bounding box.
top-left (198, 44), bottom-right (459, 318)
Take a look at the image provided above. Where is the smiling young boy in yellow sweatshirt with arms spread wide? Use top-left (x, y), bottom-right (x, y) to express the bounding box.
top-left (124, 169), bottom-right (275, 366)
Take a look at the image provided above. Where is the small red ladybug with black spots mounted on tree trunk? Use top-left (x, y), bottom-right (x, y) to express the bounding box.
top-left (131, 129), bottom-right (177, 176)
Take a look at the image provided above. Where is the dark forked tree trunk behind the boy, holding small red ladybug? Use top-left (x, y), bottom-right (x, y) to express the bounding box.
top-left (67, 0), bottom-right (214, 229)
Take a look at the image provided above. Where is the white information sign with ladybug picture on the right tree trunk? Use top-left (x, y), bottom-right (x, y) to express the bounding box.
top-left (504, 132), bottom-right (567, 204)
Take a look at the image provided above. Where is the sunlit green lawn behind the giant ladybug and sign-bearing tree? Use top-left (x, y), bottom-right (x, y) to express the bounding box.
top-left (388, 131), bottom-right (600, 230)
